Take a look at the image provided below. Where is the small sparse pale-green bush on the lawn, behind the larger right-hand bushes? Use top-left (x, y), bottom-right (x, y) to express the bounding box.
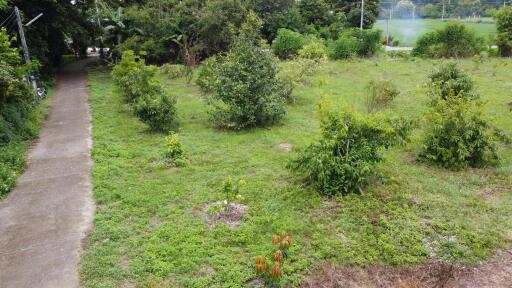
top-left (366, 80), bottom-right (400, 113)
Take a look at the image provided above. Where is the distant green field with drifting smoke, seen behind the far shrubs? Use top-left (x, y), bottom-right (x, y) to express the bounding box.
top-left (375, 19), bottom-right (496, 46)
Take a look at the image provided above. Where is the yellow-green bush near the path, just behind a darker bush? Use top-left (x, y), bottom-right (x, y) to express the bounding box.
top-left (112, 50), bottom-right (161, 102)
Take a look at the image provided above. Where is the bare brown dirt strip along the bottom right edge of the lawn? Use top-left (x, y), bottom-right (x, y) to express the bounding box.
top-left (301, 250), bottom-right (512, 288)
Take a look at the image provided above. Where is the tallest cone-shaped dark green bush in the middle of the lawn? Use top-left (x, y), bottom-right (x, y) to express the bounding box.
top-left (210, 32), bottom-right (285, 130)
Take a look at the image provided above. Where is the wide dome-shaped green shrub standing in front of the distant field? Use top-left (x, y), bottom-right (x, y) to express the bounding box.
top-left (412, 22), bottom-right (486, 57)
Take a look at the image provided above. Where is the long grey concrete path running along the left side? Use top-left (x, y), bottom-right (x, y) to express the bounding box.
top-left (0, 59), bottom-right (94, 288)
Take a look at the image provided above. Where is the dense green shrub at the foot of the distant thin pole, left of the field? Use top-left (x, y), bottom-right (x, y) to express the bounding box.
top-left (327, 29), bottom-right (382, 59)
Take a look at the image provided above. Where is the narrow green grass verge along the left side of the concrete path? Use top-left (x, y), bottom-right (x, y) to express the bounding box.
top-left (0, 90), bottom-right (52, 199)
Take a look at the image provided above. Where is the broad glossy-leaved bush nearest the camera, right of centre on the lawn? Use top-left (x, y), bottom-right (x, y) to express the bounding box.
top-left (291, 113), bottom-right (395, 195)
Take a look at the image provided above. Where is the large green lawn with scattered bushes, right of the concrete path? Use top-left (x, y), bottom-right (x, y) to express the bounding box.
top-left (81, 58), bottom-right (512, 287)
